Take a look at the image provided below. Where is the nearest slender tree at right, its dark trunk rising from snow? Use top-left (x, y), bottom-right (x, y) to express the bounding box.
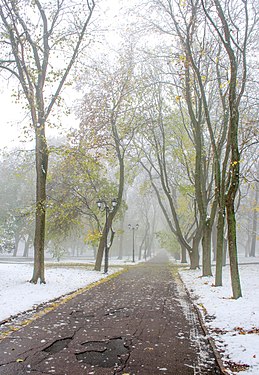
top-left (202, 0), bottom-right (257, 299)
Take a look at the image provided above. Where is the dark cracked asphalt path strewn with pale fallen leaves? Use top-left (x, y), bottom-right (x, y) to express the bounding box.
top-left (0, 256), bottom-right (221, 375)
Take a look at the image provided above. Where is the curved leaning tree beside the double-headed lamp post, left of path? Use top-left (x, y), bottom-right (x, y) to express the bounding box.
top-left (79, 51), bottom-right (138, 271)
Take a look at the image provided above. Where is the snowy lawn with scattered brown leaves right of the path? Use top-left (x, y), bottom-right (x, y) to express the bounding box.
top-left (180, 258), bottom-right (259, 375)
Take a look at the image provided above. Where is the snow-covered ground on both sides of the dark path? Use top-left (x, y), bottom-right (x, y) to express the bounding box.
top-left (0, 257), bottom-right (259, 375)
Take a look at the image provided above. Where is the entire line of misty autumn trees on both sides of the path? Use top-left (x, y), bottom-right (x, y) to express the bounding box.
top-left (0, 0), bottom-right (258, 298)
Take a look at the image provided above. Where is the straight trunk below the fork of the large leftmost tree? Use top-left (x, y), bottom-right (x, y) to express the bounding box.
top-left (30, 123), bottom-right (48, 284)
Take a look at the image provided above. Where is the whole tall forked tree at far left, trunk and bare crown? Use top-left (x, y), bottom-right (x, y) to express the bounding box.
top-left (0, 0), bottom-right (95, 283)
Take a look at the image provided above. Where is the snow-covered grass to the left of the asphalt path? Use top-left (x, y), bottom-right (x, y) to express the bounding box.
top-left (0, 264), bottom-right (122, 321)
